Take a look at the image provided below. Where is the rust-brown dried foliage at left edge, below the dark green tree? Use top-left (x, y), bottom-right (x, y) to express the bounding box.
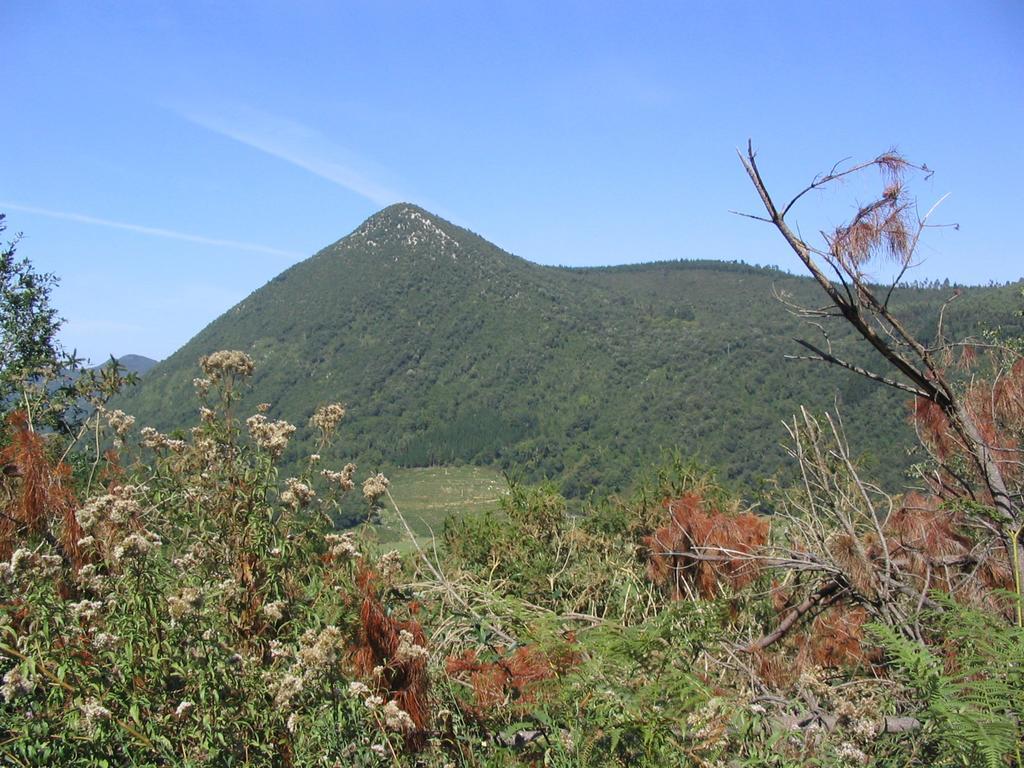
top-left (0, 411), bottom-right (83, 567)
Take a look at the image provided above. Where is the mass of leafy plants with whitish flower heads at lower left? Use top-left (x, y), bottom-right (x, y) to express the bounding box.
top-left (0, 352), bottom-right (419, 766)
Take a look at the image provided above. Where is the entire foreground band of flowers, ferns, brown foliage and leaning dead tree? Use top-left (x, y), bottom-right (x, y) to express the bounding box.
top-left (0, 153), bottom-right (1024, 767)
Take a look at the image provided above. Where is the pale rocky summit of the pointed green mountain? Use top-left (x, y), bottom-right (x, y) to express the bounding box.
top-left (345, 203), bottom-right (463, 261)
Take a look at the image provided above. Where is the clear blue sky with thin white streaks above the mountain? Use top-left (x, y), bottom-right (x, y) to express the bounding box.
top-left (0, 0), bottom-right (1024, 361)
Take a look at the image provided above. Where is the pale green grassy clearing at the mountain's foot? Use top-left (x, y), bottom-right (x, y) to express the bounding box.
top-left (374, 466), bottom-right (507, 550)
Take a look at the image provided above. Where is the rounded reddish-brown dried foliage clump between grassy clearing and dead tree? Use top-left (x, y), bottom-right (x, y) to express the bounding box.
top-left (644, 493), bottom-right (769, 600)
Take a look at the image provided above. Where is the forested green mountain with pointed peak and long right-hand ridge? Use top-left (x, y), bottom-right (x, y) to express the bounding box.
top-left (118, 204), bottom-right (1017, 496)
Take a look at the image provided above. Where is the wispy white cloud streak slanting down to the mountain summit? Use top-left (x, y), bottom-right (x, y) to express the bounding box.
top-left (178, 108), bottom-right (401, 206)
